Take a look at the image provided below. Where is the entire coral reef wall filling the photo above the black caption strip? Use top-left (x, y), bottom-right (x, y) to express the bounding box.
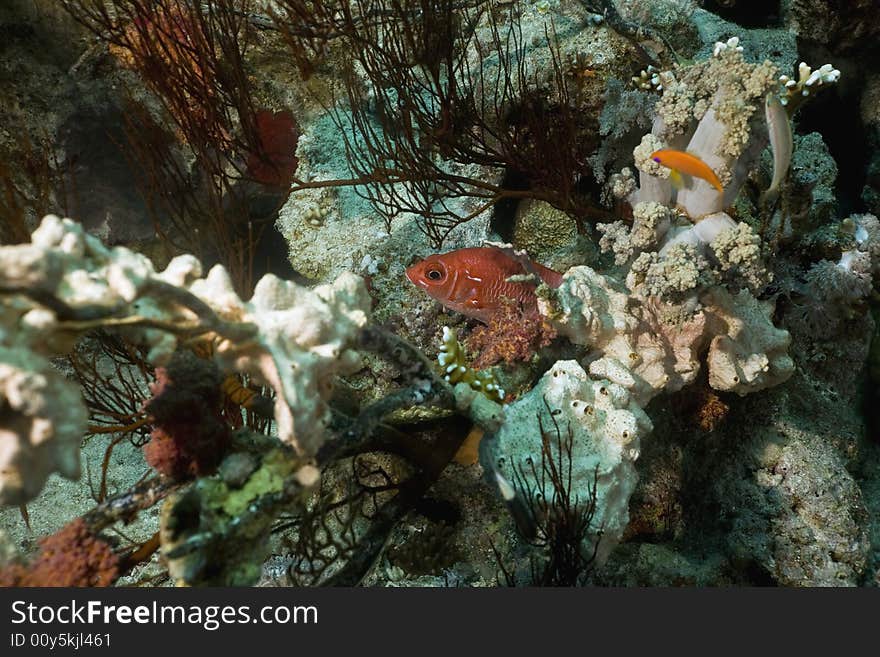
top-left (0, 0), bottom-right (880, 586)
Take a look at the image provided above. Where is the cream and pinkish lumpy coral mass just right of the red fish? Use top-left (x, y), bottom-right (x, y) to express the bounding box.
top-left (543, 264), bottom-right (794, 406)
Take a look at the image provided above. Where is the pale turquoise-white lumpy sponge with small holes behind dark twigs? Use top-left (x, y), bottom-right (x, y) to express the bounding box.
top-left (494, 360), bottom-right (651, 564)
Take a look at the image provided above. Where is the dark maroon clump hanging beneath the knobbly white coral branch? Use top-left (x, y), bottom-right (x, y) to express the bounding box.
top-left (144, 352), bottom-right (230, 479)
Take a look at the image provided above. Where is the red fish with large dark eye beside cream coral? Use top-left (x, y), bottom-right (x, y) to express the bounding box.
top-left (406, 247), bottom-right (562, 324)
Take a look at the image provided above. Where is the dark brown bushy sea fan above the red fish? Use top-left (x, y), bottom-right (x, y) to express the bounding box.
top-left (279, 0), bottom-right (603, 246)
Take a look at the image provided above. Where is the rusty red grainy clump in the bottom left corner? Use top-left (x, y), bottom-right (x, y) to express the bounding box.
top-left (0, 518), bottom-right (119, 586)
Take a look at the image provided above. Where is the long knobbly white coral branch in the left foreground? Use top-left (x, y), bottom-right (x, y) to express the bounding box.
top-left (0, 215), bottom-right (370, 502)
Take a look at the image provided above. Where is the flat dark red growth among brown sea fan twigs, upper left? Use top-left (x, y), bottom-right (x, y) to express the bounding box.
top-left (246, 110), bottom-right (299, 187)
